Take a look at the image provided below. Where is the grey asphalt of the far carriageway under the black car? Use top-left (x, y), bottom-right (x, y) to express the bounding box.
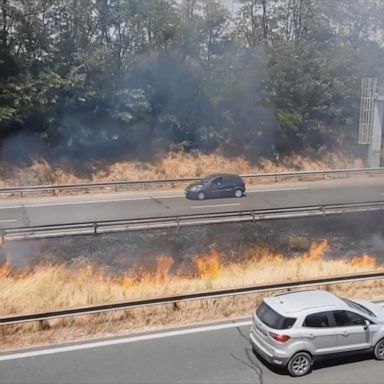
top-left (0, 177), bottom-right (384, 229)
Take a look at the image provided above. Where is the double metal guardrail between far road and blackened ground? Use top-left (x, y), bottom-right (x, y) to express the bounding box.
top-left (0, 201), bottom-right (384, 242)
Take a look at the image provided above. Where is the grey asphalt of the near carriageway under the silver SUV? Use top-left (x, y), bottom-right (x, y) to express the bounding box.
top-left (0, 321), bottom-right (384, 384)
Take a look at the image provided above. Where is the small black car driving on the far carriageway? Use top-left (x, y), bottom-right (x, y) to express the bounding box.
top-left (185, 174), bottom-right (245, 200)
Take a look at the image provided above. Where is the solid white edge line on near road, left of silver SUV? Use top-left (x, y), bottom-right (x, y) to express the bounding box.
top-left (0, 320), bottom-right (252, 361)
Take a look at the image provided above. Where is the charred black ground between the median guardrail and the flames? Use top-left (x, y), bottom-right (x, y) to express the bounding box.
top-left (0, 212), bottom-right (384, 273)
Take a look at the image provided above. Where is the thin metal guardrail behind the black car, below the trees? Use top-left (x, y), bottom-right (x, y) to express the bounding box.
top-left (0, 168), bottom-right (384, 196)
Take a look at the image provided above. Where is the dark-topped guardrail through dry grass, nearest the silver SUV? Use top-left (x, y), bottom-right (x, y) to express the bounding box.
top-left (0, 271), bottom-right (384, 325)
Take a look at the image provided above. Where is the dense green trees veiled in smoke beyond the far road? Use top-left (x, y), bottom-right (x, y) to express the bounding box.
top-left (0, 0), bottom-right (384, 160)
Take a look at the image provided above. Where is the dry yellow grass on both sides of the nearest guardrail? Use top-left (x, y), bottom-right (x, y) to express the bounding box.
top-left (0, 241), bottom-right (384, 348)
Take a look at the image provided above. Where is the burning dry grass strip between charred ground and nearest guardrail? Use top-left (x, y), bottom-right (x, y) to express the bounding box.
top-left (0, 241), bottom-right (379, 315)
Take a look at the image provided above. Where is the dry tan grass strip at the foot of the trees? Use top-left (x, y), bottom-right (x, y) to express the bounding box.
top-left (0, 152), bottom-right (363, 188)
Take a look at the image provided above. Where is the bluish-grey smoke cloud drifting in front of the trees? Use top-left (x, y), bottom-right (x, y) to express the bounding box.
top-left (0, 13), bottom-right (277, 164)
